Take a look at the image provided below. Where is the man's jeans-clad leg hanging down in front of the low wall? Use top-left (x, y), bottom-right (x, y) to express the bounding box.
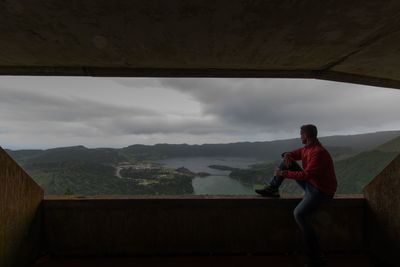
top-left (293, 185), bottom-right (331, 258)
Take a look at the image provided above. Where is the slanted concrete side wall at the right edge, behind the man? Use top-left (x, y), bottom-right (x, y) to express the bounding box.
top-left (364, 155), bottom-right (400, 266)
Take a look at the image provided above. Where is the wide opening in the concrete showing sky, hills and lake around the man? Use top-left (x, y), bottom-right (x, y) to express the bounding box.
top-left (0, 76), bottom-right (400, 196)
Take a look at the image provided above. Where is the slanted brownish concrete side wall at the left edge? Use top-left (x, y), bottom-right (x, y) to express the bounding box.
top-left (0, 148), bottom-right (43, 267)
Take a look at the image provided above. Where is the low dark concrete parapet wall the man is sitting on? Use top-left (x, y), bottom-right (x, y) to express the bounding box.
top-left (43, 196), bottom-right (364, 255)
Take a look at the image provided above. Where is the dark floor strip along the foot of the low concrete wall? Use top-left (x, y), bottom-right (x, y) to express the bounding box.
top-left (32, 254), bottom-right (374, 267)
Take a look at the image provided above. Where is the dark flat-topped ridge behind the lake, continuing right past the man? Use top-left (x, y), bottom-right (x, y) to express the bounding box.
top-left (122, 131), bottom-right (400, 160)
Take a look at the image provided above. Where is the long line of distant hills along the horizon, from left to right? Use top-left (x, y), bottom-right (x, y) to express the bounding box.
top-left (7, 131), bottom-right (400, 164)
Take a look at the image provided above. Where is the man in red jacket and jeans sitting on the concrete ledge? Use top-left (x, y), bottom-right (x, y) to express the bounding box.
top-left (256, 124), bottom-right (337, 266)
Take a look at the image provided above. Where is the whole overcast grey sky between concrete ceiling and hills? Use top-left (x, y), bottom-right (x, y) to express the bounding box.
top-left (0, 76), bottom-right (400, 149)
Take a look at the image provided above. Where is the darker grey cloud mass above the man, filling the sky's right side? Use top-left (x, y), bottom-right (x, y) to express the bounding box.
top-left (161, 79), bottom-right (400, 135)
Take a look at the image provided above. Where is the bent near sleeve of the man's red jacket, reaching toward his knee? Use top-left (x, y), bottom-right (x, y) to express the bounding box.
top-left (282, 151), bottom-right (324, 180)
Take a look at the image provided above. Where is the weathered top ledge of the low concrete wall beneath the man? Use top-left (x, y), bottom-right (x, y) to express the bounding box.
top-left (43, 194), bottom-right (365, 209)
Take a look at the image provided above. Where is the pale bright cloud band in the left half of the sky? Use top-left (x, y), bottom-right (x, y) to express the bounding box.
top-left (0, 88), bottom-right (226, 138)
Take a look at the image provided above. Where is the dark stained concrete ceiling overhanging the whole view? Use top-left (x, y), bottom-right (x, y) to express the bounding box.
top-left (0, 0), bottom-right (400, 88)
